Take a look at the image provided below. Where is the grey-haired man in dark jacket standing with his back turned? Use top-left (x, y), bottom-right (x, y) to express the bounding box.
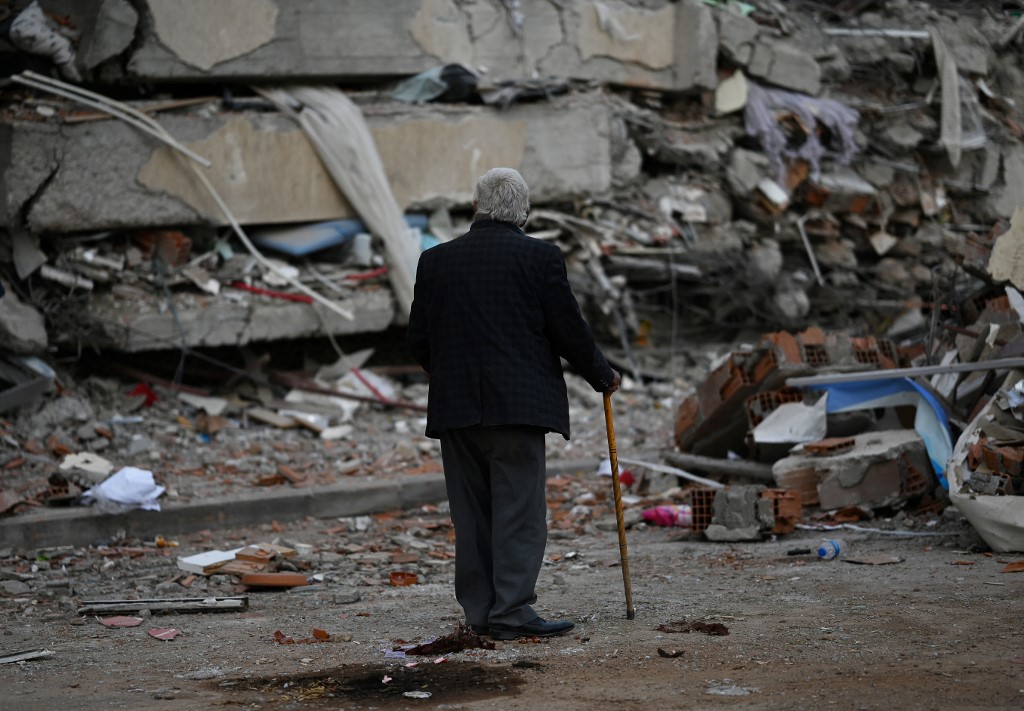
top-left (407, 168), bottom-right (620, 639)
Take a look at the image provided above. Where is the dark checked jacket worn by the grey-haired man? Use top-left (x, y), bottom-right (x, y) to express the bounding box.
top-left (406, 219), bottom-right (614, 440)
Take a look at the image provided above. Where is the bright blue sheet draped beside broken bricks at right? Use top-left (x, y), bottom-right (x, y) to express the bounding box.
top-left (808, 378), bottom-right (953, 491)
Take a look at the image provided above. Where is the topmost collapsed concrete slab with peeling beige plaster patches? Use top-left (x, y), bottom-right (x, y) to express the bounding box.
top-left (128, 0), bottom-right (718, 90)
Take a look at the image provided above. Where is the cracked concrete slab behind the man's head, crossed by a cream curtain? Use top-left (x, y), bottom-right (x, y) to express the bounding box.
top-left (0, 93), bottom-right (612, 233)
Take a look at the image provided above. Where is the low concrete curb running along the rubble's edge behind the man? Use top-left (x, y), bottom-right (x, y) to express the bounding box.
top-left (0, 460), bottom-right (598, 549)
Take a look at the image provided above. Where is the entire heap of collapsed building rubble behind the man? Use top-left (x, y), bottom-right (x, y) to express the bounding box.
top-left (0, 0), bottom-right (1024, 549)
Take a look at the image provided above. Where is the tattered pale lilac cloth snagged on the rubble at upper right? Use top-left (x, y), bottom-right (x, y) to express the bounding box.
top-left (743, 82), bottom-right (860, 181)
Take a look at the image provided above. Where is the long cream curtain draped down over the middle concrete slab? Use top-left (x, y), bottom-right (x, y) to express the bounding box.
top-left (260, 86), bottom-right (419, 322)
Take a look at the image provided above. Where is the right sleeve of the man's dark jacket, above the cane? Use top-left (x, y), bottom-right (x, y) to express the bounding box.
top-left (542, 250), bottom-right (614, 392)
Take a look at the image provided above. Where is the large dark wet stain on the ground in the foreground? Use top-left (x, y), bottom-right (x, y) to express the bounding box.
top-left (215, 661), bottom-right (522, 709)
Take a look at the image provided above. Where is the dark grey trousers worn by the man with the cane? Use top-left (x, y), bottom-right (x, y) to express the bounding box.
top-left (440, 426), bottom-right (548, 625)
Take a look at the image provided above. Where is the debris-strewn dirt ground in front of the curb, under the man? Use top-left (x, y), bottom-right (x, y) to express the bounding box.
top-left (0, 474), bottom-right (1024, 711)
